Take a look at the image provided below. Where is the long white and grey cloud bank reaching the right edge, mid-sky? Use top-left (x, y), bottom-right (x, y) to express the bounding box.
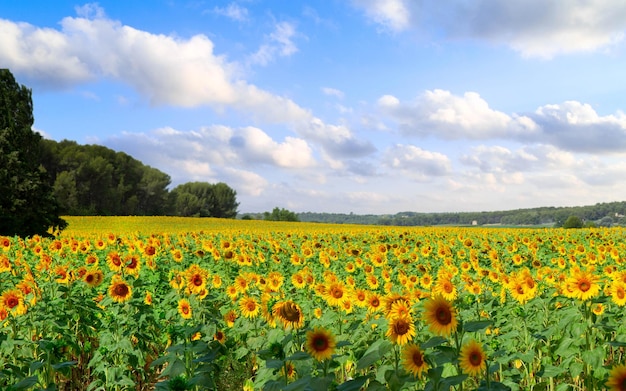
top-left (378, 90), bottom-right (626, 153)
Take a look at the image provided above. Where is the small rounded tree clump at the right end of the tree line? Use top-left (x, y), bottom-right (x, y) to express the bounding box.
top-left (170, 182), bottom-right (239, 218)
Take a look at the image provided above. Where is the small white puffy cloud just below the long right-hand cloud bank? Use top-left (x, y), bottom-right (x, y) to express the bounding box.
top-left (383, 144), bottom-right (452, 180)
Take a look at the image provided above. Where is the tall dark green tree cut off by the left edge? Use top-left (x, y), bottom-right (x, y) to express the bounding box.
top-left (0, 69), bottom-right (67, 236)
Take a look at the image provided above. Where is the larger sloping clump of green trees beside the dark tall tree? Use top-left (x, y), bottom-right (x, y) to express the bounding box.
top-left (42, 140), bottom-right (170, 216)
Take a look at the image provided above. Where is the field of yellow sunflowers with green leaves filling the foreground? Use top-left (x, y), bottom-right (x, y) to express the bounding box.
top-left (0, 217), bottom-right (626, 391)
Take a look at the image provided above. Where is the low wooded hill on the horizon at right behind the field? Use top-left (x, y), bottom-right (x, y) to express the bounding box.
top-left (297, 201), bottom-right (626, 227)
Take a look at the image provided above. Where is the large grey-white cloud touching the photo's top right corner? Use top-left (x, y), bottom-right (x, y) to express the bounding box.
top-left (353, 0), bottom-right (626, 58)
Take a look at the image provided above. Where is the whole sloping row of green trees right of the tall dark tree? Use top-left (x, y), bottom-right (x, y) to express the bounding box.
top-left (40, 140), bottom-right (239, 218)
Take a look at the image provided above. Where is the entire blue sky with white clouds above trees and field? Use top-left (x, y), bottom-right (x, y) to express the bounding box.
top-left (0, 0), bottom-right (626, 214)
